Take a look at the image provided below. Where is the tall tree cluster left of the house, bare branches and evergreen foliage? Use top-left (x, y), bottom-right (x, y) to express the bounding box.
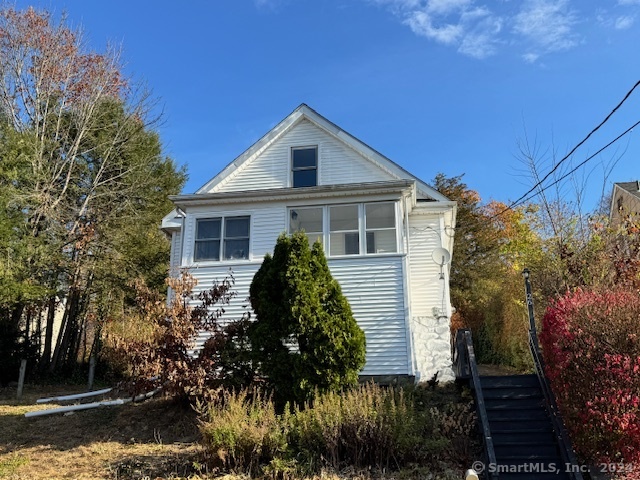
top-left (0, 7), bottom-right (184, 378)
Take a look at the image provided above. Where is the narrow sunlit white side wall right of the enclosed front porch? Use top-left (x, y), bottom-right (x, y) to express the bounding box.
top-left (408, 215), bottom-right (455, 381)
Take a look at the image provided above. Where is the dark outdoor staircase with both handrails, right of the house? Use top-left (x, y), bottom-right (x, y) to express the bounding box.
top-left (453, 270), bottom-right (582, 480)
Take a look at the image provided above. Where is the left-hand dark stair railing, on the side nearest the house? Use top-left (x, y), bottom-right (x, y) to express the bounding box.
top-left (453, 329), bottom-right (498, 479)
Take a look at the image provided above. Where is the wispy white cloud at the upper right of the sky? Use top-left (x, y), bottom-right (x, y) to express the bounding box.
top-left (372, 0), bottom-right (592, 63)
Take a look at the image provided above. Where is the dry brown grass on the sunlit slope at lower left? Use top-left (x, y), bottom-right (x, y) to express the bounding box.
top-left (0, 386), bottom-right (461, 480)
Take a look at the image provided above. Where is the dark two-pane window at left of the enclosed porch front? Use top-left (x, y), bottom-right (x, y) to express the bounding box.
top-left (193, 216), bottom-right (250, 262)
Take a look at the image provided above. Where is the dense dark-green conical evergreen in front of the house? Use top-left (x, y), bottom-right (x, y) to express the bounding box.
top-left (249, 232), bottom-right (365, 405)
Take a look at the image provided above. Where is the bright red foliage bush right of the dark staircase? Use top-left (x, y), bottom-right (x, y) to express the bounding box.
top-left (540, 289), bottom-right (640, 463)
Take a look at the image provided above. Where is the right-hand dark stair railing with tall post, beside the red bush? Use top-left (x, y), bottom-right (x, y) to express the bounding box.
top-left (522, 268), bottom-right (583, 480)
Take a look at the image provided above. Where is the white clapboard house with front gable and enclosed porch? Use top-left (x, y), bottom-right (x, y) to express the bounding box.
top-left (162, 104), bottom-right (456, 381)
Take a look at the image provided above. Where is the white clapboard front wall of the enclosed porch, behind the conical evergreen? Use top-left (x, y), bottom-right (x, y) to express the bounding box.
top-left (172, 197), bottom-right (412, 375)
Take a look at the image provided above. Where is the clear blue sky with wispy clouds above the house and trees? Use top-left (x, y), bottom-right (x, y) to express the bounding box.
top-left (16, 0), bottom-right (640, 207)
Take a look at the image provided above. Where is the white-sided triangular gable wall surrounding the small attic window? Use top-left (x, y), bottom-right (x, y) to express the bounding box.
top-left (211, 120), bottom-right (397, 193)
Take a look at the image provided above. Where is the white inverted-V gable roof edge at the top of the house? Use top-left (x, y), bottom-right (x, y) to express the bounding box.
top-left (196, 103), bottom-right (448, 201)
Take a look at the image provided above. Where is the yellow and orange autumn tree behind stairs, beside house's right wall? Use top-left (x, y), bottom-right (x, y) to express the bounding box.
top-left (433, 174), bottom-right (542, 368)
